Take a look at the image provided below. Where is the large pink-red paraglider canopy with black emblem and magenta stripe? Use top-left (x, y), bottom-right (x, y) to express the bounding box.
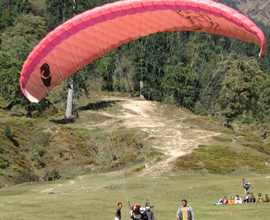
top-left (20, 0), bottom-right (265, 102)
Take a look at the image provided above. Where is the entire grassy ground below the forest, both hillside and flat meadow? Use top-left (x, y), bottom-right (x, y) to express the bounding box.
top-left (0, 96), bottom-right (270, 220)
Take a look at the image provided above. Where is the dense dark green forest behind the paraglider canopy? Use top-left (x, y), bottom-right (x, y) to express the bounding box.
top-left (0, 0), bottom-right (270, 135)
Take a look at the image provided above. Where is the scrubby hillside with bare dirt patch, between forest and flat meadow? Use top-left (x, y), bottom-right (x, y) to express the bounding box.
top-left (0, 94), bottom-right (270, 185)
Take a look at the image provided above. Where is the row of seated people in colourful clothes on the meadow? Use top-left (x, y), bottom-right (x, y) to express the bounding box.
top-left (215, 193), bottom-right (269, 205)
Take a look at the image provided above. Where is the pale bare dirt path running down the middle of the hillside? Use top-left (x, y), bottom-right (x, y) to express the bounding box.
top-left (100, 99), bottom-right (219, 175)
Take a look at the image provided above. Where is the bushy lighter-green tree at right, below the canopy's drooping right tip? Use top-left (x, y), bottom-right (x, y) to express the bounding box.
top-left (219, 58), bottom-right (267, 124)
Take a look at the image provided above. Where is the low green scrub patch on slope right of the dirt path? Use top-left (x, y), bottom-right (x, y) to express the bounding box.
top-left (173, 145), bottom-right (270, 174)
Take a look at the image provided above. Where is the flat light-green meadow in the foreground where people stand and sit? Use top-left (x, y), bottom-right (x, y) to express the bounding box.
top-left (0, 171), bottom-right (270, 220)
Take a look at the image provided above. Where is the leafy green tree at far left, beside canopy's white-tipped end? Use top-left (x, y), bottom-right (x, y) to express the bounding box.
top-left (0, 14), bottom-right (49, 111)
